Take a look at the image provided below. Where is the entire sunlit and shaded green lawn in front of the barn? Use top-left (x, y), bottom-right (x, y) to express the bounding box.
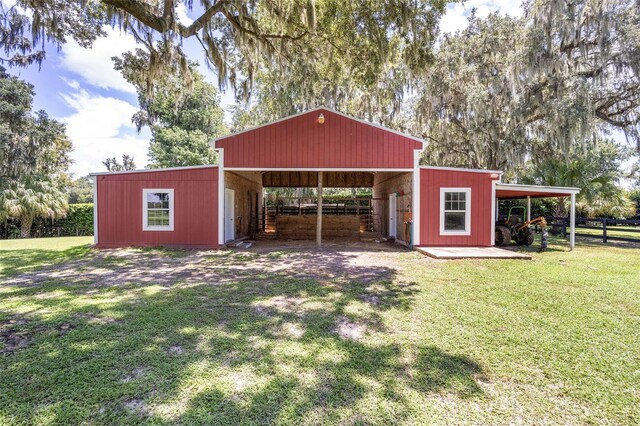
top-left (0, 239), bottom-right (640, 425)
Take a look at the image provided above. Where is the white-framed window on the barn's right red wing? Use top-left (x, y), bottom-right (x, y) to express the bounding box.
top-left (440, 188), bottom-right (471, 235)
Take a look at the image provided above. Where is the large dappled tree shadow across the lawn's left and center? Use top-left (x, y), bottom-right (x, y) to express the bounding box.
top-left (0, 248), bottom-right (482, 424)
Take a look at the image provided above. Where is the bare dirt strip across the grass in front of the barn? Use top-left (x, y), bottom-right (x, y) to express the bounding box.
top-left (5, 243), bottom-right (406, 293)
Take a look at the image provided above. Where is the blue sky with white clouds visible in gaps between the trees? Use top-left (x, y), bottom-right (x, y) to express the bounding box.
top-left (9, 0), bottom-right (522, 176)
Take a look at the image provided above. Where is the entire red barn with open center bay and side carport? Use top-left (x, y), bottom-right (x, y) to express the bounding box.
top-left (93, 108), bottom-right (577, 248)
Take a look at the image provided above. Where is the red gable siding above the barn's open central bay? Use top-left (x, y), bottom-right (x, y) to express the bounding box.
top-left (216, 109), bottom-right (422, 169)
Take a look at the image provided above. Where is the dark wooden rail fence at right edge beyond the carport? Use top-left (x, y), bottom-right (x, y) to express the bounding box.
top-left (546, 216), bottom-right (640, 243)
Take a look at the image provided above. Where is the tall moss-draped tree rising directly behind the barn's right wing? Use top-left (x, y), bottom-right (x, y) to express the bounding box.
top-left (413, 14), bottom-right (531, 170)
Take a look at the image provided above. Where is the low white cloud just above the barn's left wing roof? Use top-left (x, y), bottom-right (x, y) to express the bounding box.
top-left (60, 90), bottom-right (149, 176)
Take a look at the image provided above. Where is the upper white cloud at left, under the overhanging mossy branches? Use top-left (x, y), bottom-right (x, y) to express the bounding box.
top-left (60, 28), bottom-right (137, 93)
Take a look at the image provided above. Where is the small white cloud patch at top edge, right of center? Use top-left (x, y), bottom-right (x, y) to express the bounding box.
top-left (440, 0), bottom-right (523, 34)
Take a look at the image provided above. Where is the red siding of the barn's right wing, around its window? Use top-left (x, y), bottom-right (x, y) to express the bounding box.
top-left (420, 168), bottom-right (494, 247)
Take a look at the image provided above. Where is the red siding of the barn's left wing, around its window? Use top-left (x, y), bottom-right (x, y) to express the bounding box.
top-left (96, 167), bottom-right (218, 248)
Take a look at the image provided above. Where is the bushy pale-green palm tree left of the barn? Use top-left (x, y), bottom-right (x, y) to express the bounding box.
top-left (0, 177), bottom-right (68, 238)
